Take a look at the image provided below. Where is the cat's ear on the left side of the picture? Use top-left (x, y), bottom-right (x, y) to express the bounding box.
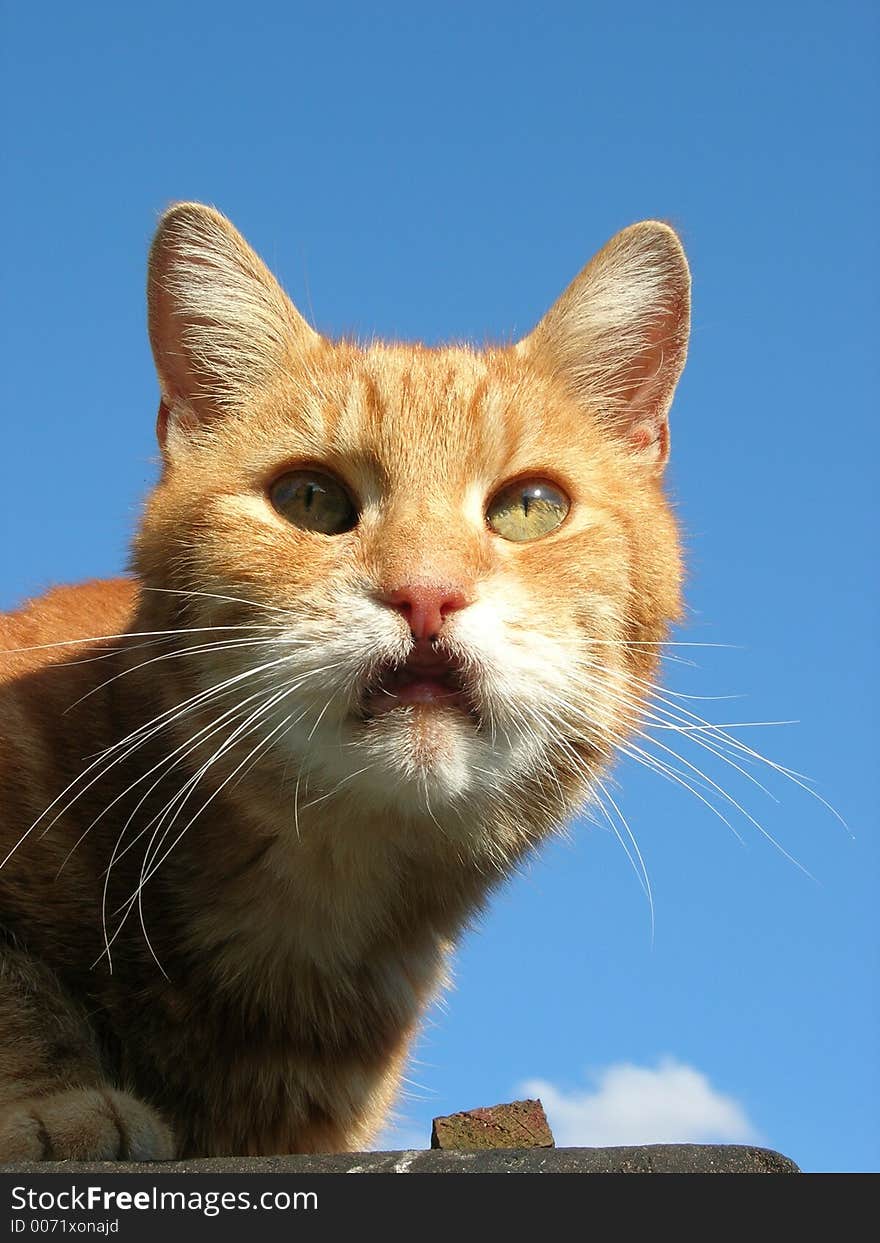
top-left (147, 203), bottom-right (321, 447)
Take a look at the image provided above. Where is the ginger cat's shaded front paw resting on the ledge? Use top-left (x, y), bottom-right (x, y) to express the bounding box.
top-left (0, 1088), bottom-right (174, 1161)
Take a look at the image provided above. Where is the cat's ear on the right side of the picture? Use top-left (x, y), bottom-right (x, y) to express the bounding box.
top-left (516, 220), bottom-right (691, 467)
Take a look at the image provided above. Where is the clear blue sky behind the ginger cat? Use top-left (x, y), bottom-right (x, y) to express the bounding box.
top-left (0, 0), bottom-right (880, 1170)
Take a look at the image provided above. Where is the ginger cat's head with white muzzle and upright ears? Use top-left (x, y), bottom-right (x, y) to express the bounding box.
top-left (134, 204), bottom-right (690, 845)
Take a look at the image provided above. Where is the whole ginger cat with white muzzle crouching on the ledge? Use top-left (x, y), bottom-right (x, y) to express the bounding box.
top-left (0, 204), bottom-right (690, 1161)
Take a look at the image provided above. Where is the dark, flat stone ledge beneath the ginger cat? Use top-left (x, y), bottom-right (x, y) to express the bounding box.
top-left (0, 1144), bottom-right (800, 1177)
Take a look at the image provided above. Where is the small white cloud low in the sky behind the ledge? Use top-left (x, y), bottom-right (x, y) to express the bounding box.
top-left (520, 1058), bottom-right (759, 1147)
